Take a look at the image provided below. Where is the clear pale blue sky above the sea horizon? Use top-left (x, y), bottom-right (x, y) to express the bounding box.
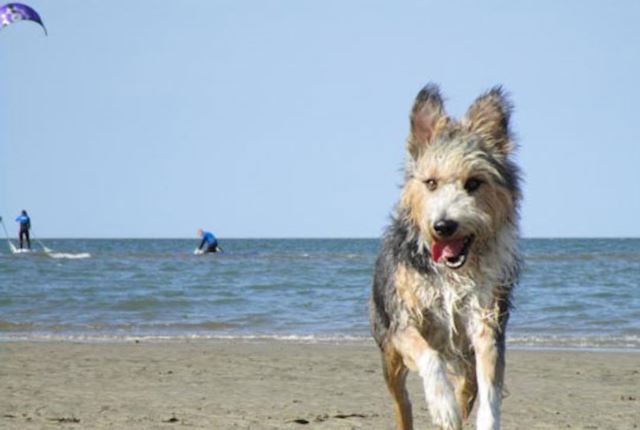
top-left (0, 0), bottom-right (640, 237)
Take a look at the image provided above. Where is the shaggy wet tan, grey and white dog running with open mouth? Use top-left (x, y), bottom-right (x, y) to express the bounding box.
top-left (369, 84), bottom-right (521, 430)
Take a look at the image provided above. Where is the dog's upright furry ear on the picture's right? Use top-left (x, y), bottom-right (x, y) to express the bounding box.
top-left (464, 86), bottom-right (514, 156)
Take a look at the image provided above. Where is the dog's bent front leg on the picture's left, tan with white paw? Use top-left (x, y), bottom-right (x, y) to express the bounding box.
top-left (393, 327), bottom-right (462, 430)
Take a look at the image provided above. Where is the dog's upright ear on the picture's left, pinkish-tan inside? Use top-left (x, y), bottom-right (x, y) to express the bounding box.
top-left (407, 83), bottom-right (447, 159)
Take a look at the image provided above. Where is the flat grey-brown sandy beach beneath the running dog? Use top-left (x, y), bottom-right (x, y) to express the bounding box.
top-left (0, 341), bottom-right (640, 430)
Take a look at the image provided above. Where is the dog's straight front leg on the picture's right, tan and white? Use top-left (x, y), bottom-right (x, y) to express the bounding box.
top-left (473, 321), bottom-right (505, 430)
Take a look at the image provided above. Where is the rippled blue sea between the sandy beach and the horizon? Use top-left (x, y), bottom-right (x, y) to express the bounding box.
top-left (0, 239), bottom-right (640, 350)
